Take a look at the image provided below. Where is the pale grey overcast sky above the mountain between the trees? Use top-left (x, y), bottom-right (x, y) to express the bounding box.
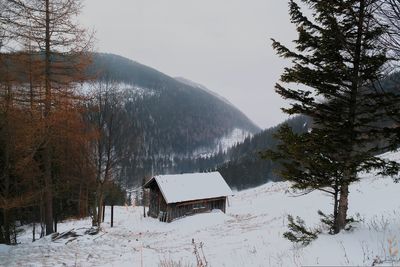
top-left (82, 0), bottom-right (296, 128)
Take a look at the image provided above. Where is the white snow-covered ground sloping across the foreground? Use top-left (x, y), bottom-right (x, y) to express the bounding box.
top-left (0, 154), bottom-right (400, 267)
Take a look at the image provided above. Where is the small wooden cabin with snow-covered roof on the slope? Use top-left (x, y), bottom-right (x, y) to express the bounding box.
top-left (144, 172), bottom-right (233, 222)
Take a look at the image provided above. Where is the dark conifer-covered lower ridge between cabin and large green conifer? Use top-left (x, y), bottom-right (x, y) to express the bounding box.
top-left (166, 116), bottom-right (311, 190)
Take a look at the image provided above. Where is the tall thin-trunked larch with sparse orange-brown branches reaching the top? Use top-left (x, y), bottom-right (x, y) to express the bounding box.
top-left (3, 0), bottom-right (90, 235)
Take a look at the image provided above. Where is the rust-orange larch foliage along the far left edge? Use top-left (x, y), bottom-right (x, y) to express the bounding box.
top-left (0, 53), bottom-right (45, 243)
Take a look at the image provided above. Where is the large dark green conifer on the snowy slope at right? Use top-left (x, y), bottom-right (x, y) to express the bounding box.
top-left (265, 0), bottom-right (397, 233)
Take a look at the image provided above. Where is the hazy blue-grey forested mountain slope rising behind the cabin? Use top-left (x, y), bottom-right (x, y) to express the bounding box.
top-left (89, 53), bottom-right (260, 185)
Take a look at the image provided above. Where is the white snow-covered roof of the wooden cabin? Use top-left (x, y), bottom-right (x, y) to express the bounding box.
top-left (145, 172), bottom-right (233, 204)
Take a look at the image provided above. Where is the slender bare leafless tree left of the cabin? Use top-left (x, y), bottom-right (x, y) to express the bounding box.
top-left (89, 82), bottom-right (130, 226)
